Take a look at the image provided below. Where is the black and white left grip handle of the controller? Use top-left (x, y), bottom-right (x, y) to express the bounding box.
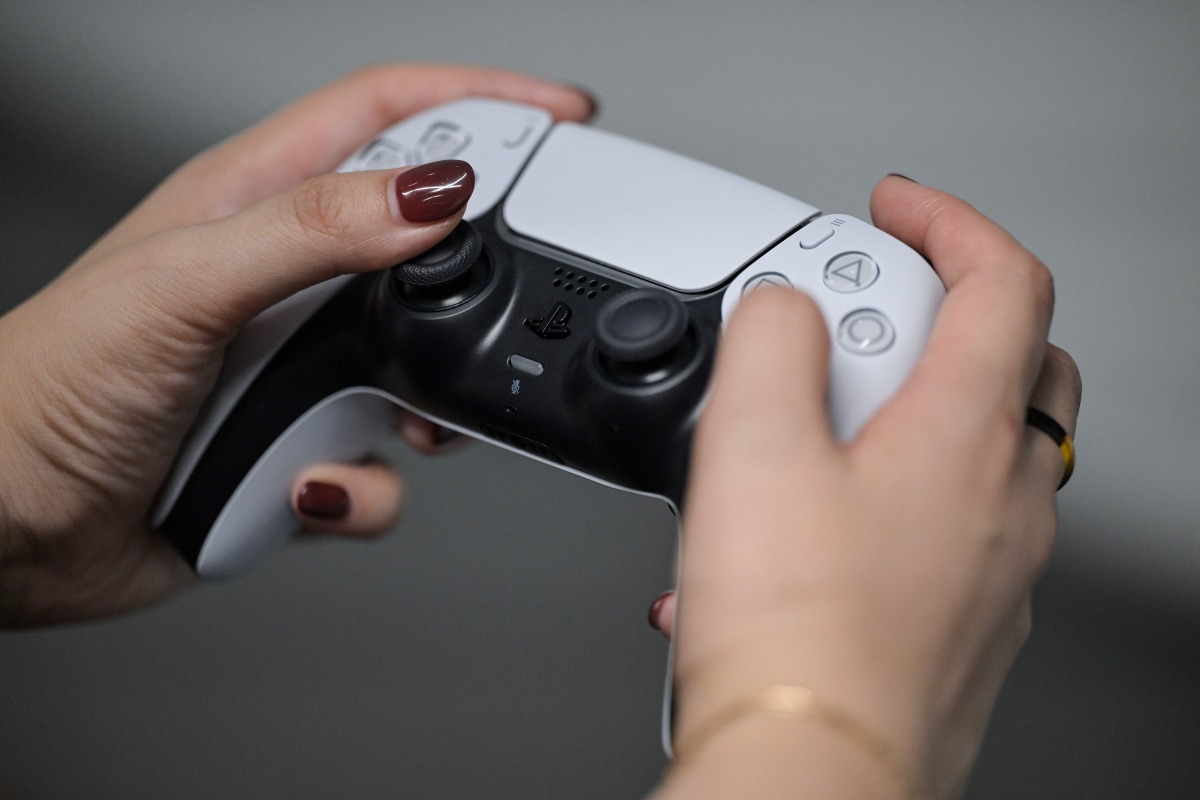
top-left (158, 276), bottom-right (394, 578)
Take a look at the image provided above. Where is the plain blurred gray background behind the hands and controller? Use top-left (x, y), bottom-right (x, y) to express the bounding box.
top-left (0, 0), bottom-right (1200, 799)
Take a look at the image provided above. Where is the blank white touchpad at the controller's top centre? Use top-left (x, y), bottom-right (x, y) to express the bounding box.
top-left (504, 122), bottom-right (818, 291)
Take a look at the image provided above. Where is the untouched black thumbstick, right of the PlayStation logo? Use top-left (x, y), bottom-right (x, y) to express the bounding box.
top-left (595, 289), bottom-right (689, 380)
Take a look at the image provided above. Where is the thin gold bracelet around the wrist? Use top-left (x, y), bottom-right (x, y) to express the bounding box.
top-left (674, 685), bottom-right (926, 800)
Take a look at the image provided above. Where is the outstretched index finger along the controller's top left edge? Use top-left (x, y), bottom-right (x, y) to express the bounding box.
top-left (86, 64), bottom-right (594, 260)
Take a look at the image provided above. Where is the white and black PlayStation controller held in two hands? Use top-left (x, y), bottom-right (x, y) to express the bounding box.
top-left (154, 100), bottom-right (944, 578)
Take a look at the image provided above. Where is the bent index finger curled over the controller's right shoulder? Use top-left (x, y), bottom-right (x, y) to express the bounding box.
top-left (871, 178), bottom-right (1054, 441)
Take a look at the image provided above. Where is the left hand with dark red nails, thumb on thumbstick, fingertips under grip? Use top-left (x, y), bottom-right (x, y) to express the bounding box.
top-left (0, 65), bottom-right (593, 626)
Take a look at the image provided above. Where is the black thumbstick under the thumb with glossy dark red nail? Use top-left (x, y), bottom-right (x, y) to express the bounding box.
top-left (391, 219), bottom-right (491, 311)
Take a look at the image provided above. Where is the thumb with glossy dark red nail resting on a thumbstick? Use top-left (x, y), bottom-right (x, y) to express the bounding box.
top-left (131, 161), bottom-right (475, 339)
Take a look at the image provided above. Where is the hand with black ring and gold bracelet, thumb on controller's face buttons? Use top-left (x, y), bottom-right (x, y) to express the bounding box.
top-left (652, 178), bottom-right (1080, 798)
